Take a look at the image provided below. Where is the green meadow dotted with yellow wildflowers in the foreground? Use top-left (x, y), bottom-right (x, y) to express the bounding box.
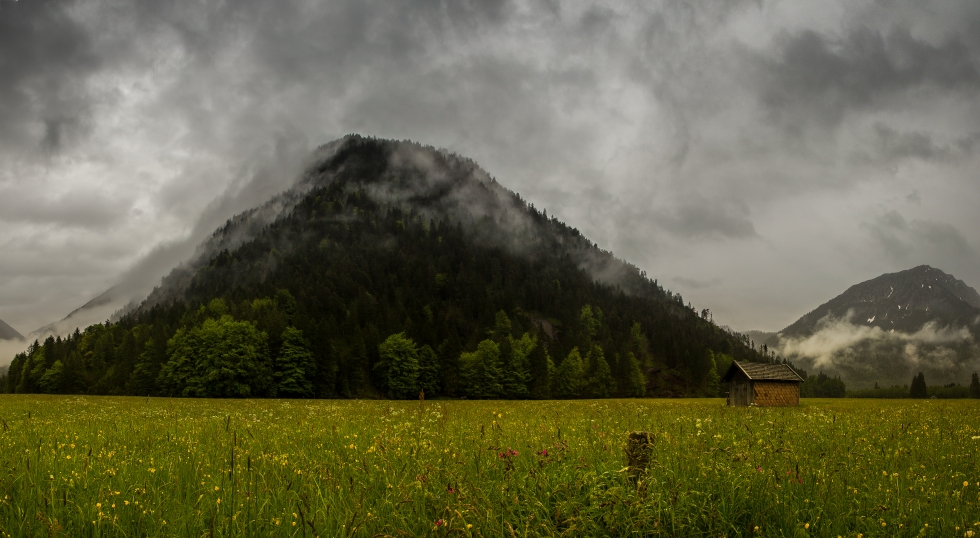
top-left (0, 396), bottom-right (980, 538)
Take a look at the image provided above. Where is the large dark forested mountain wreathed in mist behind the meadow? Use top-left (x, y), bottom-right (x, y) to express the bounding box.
top-left (0, 135), bottom-right (775, 398)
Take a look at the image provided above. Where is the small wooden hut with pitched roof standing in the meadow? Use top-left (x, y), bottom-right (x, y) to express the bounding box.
top-left (722, 361), bottom-right (803, 407)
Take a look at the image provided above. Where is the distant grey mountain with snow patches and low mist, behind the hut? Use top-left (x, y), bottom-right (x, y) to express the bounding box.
top-left (766, 265), bottom-right (980, 387)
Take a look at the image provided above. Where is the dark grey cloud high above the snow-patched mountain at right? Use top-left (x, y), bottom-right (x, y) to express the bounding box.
top-left (757, 26), bottom-right (980, 130)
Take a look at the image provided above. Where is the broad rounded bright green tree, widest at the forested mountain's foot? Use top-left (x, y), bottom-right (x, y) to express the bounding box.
top-left (160, 316), bottom-right (272, 398)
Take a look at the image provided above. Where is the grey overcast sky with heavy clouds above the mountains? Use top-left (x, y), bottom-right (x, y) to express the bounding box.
top-left (0, 0), bottom-right (980, 348)
